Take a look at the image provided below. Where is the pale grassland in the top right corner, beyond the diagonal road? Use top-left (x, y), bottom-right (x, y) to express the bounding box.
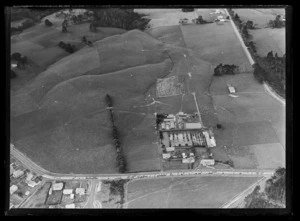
top-left (233, 8), bottom-right (285, 56)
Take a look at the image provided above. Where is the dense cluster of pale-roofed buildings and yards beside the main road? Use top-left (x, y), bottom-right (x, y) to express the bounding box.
top-left (158, 112), bottom-right (216, 166)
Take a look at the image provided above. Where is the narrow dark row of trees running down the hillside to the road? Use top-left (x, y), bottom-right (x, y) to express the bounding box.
top-left (105, 94), bottom-right (126, 173)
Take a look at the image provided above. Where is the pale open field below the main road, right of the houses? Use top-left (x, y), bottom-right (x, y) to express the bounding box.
top-left (125, 176), bottom-right (260, 208)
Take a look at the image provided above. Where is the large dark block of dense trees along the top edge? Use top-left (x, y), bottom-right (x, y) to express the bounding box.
top-left (90, 8), bottom-right (150, 31)
